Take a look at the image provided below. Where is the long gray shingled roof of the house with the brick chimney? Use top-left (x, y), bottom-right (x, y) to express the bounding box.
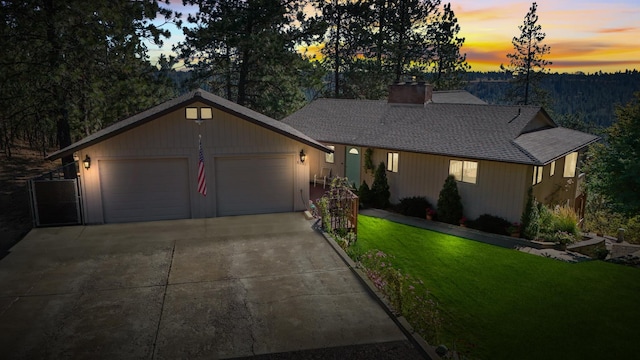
top-left (282, 97), bottom-right (598, 165)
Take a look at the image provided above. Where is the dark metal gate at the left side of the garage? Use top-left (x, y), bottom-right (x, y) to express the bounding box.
top-left (27, 164), bottom-right (82, 227)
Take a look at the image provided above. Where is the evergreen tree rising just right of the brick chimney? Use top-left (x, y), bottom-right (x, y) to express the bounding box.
top-left (428, 3), bottom-right (471, 90)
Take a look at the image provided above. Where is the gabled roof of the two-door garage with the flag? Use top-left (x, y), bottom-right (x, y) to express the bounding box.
top-left (46, 89), bottom-right (332, 160)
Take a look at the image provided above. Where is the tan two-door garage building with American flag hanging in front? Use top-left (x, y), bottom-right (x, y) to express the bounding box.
top-left (48, 90), bottom-right (331, 224)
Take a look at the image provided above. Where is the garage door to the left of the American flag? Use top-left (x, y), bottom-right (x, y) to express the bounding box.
top-left (98, 159), bottom-right (191, 223)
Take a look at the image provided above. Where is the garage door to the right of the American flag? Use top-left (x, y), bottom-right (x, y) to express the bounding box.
top-left (216, 156), bottom-right (294, 216)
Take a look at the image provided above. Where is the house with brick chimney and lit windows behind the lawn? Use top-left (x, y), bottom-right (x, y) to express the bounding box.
top-left (282, 83), bottom-right (598, 222)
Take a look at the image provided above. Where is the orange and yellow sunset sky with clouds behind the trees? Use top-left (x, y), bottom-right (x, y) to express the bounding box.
top-left (156, 0), bottom-right (640, 73)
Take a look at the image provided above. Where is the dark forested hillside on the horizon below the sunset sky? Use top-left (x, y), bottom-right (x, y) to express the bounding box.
top-left (465, 70), bottom-right (640, 127)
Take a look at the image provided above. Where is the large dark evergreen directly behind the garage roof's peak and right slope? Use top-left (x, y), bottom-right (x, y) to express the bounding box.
top-left (177, 0), bottom-right (316, 118)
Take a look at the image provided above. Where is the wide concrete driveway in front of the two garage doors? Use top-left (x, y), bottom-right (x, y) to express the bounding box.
top-left (0, 213), bottom-right (417, 359)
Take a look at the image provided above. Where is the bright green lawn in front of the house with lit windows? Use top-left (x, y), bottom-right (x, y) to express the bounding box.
top-left (354, 216), bottom-right (640, 359)
